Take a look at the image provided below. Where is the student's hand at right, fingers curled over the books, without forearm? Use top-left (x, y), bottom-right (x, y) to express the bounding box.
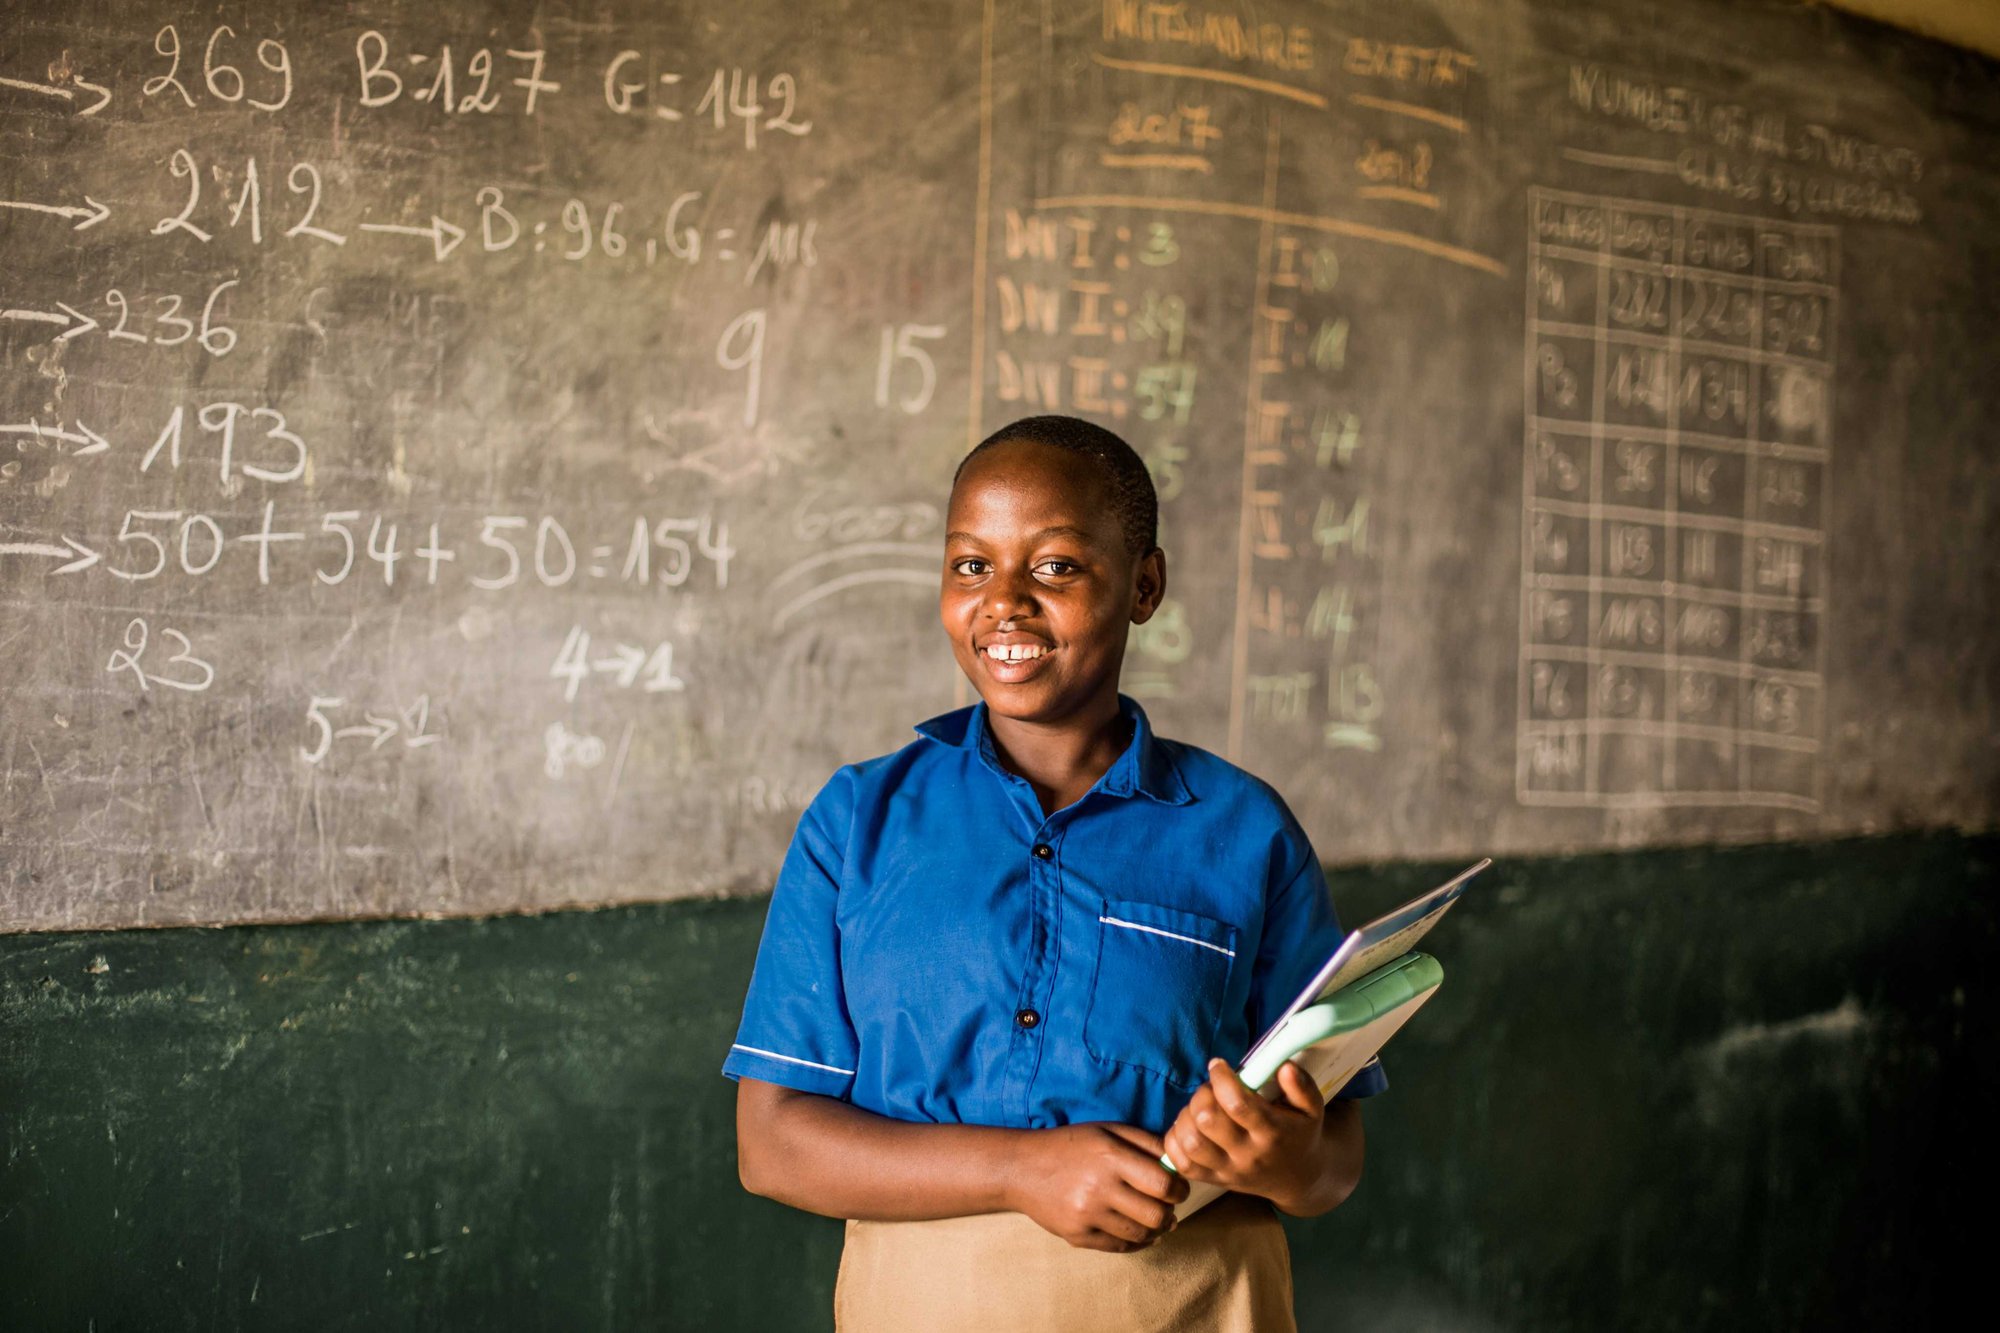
top-left (1164, 1061), bottom-right (1326, 1211)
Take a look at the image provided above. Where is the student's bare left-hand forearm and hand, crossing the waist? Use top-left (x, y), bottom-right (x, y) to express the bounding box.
top-left (736, 1079), bottom-right (1188, 1251)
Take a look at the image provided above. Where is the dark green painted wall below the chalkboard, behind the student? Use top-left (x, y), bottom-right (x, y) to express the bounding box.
top-left (0, 835), bottom-right (2000, 1333)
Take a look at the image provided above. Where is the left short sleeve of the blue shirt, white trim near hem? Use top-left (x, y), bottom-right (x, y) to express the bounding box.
top-left (722, 769), bottom-right (858, 1097)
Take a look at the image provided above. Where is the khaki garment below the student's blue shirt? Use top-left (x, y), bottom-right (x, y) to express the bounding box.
top-left (834, 1195), bottom-right (1298, 1333)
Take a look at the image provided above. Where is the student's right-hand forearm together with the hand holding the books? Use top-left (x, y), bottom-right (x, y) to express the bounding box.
top-left (1166, 1061), bottom-right (1362, 1217)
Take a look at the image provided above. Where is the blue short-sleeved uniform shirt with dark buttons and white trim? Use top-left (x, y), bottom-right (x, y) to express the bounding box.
top-left (722, 697), bottom-right (1386, 1133)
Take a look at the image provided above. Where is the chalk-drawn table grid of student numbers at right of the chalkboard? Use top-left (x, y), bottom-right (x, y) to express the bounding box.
top-left (1516, 190), bottom-right (1838, 811)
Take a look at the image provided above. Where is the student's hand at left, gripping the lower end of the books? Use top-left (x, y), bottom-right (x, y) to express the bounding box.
top-left (1012, 1123), bottom-right (1188, 1253)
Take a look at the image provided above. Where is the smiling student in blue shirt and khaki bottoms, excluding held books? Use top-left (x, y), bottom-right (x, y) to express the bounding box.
top-left (724, 416), bottom-right (1384, 1333)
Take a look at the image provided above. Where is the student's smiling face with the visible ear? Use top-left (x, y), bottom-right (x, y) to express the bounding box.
top-left (938, 440), bottom-right (1166, 725)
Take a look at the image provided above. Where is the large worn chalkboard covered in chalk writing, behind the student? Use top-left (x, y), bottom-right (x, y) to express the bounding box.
top-left (0, 0), bottom-right (2000, 931)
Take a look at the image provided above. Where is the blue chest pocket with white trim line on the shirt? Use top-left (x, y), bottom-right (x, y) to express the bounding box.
top-left (1084, 899), bottom-right (1236, 1087)
